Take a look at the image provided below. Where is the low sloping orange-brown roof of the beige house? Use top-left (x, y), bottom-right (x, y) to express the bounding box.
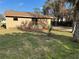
top-left (5, 11), bottom-right (53, 18)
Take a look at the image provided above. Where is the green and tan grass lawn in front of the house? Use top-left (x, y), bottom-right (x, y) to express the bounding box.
top-left (0, 30), bottom-right (79, 59)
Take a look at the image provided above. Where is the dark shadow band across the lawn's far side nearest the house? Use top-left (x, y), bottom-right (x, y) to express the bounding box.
top-left (0, 32), bottom-right (79, 49)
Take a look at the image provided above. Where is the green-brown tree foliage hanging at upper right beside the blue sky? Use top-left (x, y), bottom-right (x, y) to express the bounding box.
top-left (43, 0), bottom-right (76, 17)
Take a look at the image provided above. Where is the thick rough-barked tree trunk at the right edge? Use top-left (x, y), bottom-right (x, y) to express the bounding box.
top-left (73, 0), bottom-right (79, 42)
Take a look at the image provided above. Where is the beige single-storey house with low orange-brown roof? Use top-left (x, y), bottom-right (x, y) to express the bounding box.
top-left (5, 11), bottom-right (53, 29)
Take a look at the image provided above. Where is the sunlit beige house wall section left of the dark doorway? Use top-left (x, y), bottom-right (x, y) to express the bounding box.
top-left (6, 17), bottom-right (32, 29)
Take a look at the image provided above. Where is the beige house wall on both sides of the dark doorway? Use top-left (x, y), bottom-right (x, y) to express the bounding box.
top-left (6, 17), bottom-right (51, 29)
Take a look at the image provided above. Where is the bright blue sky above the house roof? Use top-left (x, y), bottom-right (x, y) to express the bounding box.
top-left (0, 0), bottom-right (46, 14)
